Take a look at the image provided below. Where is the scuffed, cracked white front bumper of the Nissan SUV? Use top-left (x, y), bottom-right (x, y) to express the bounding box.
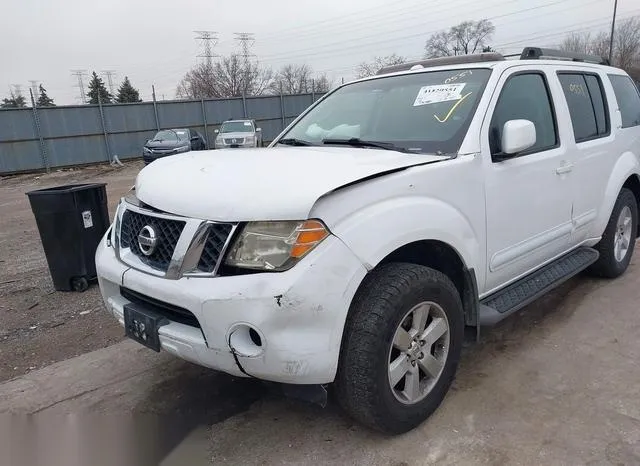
top-left (96, 233), bottom-right (366, 384)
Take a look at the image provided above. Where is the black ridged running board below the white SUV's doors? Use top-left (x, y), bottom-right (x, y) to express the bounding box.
top-left (479, 247), bottom-right (599, 325)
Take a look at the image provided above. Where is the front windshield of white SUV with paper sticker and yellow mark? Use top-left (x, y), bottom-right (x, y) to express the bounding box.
top-left (283, 68), bottom-right (491, 154)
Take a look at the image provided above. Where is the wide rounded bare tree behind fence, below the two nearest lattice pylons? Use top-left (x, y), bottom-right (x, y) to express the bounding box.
top-left (176, 55), bottom-right (273, 99)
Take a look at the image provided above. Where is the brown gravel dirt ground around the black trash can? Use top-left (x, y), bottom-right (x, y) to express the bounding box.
top-left (0, 161), bottom-right (143, 380)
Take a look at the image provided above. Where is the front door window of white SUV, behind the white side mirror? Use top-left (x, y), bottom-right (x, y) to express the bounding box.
top-left (489, 72), bottom-right (558, 155)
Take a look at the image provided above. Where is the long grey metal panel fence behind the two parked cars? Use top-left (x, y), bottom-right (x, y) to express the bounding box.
top-left (0, 93), bottom-right (322, 175)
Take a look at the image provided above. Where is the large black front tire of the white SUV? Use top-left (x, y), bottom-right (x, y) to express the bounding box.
top-left (335, 263), bottom-right (464, 434)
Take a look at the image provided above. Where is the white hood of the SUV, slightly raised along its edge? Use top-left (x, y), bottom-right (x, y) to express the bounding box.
top-left (136, 147), bottom-right (446, 222)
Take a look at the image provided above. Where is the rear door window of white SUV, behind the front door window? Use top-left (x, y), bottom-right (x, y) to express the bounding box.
top-left (558, 73), bottom-right (609, 142)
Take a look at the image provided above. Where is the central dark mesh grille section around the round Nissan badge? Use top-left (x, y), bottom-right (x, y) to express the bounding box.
top-left (120, 210), bottom-right (185, 272)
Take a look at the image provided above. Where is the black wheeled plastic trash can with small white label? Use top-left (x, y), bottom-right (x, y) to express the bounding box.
top-left (27, 183), bottom-right (110, 291)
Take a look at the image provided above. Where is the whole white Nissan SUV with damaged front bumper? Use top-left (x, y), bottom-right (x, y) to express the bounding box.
top-left (96, 49), bottom-right (640, 433)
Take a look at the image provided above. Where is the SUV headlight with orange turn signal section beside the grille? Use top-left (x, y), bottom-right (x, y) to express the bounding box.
top-left (226, 220), bottom-right (329, 271)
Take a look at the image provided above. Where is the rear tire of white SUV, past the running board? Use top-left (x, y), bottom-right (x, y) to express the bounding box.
top-left (589, 188), bottom-right (638, 278)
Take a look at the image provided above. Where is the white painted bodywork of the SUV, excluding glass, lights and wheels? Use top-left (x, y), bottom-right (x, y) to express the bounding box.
top-left (96, 60), bottom-right (640, 384)
